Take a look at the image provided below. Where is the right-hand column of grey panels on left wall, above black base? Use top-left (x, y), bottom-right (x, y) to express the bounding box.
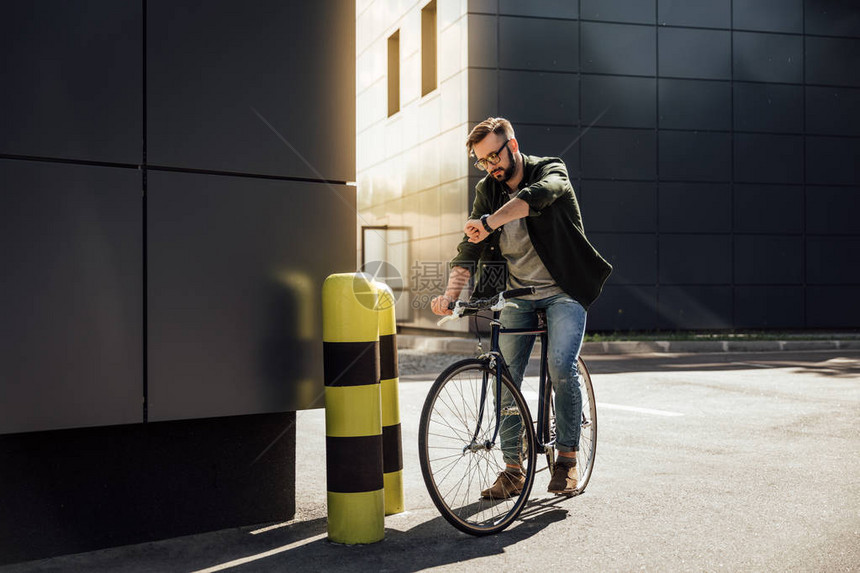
top-left (146, 0), bottom-right (356, 421)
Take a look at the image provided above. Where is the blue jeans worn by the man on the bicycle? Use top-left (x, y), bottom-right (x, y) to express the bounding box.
top-left (499, 293), bottom-right (586, 465)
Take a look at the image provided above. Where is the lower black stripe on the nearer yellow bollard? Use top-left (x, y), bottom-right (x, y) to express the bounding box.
top-left (325, 435), bottom-right (383, 493)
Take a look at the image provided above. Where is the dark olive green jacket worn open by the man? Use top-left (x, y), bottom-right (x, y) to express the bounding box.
top-left (451, 155), bottom-right (612, 309)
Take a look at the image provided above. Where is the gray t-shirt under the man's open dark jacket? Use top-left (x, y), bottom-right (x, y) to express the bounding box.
top-left (499, 194), bottom-right (564, 300)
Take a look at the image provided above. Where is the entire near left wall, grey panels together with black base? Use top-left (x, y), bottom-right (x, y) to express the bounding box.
top-left (0, 0), bottom-right (356, 564)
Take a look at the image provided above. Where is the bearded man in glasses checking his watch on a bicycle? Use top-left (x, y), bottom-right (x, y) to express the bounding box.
top-left (431, 117), bottom-right (612, 499)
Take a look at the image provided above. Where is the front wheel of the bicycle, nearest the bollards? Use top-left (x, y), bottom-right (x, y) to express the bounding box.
top-left (418, 359), bottom-right (535, 535)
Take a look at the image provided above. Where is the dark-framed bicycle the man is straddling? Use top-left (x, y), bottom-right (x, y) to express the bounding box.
top-left (418, 288), bottom-right (597, 535)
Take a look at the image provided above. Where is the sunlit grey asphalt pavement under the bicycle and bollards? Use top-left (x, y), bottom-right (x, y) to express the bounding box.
top-left (0, 348), bottom-right (860, 573)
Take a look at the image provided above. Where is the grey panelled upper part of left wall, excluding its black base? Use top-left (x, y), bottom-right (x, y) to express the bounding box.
top-left (0, 0), bottom-right (355, 433)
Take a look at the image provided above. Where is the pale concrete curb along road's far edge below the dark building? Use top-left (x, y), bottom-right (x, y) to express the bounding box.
top-left (397, 334), bottom-right (860, 356)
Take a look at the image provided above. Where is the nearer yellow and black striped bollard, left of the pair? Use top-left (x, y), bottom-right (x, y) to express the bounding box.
top-left (323, 273), bottom-right (385, 544)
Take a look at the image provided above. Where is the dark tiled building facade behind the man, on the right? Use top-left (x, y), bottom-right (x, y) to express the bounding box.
top-left (469, 0), bottom-right (860, 330)
